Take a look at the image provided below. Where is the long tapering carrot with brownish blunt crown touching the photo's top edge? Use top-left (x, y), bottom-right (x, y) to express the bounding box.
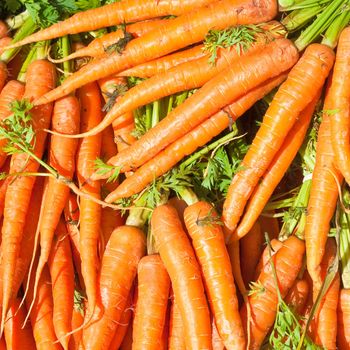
top-left (35, 0), bottom-right (277, 104)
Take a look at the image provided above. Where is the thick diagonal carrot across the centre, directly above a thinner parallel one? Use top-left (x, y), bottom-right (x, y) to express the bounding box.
top-left (100, 39), bottom-right (298, 175)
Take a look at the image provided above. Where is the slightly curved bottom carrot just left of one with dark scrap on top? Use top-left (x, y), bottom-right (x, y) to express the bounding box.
top-left (151, 205), bottom-right (211, 350)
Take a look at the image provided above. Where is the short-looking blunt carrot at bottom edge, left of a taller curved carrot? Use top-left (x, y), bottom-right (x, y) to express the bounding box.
top-left (133, 255), bottom-right (170, 349)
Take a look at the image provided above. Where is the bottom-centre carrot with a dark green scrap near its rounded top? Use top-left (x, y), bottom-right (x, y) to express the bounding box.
top-left (184, 202), bottom-right (246, 350)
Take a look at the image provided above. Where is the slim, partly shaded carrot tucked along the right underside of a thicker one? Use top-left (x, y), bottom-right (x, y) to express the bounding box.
top-left (235, 91), bottom-right (321, 238)
